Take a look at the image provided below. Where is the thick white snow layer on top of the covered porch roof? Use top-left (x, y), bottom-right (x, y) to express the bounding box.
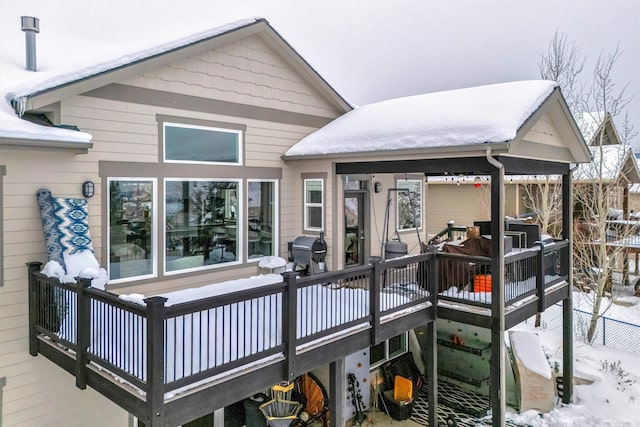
top-left (285, 80), bottom-right (557, 157)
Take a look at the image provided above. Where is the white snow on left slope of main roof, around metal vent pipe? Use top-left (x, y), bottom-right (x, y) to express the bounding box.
top-left (0, 18), bottom-right (259, 144)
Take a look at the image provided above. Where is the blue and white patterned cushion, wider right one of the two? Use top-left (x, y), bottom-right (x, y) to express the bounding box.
top-left (53, 197), bottom-right (93, 255)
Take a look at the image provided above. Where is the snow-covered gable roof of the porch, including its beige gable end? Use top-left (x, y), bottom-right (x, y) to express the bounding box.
top-left (285, 80), bottom-right (590, 162)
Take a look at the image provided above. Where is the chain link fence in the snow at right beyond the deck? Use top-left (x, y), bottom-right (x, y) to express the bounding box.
top-left (530, 304), bottom-right (640, 356)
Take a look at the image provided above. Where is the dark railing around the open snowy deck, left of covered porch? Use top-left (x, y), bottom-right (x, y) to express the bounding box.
top-left (29, 253), bottom-right (435, 406)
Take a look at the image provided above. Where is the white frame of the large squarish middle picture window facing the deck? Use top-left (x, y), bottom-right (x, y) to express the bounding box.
top-left (164, 177), bottom-right (245, 277)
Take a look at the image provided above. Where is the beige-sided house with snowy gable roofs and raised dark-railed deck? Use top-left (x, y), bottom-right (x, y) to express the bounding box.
top-left (0, 15), bottom-right (590, 426)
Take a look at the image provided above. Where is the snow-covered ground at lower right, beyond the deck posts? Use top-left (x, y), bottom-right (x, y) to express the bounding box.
top-left (507, 287), bottom-right (640, 427)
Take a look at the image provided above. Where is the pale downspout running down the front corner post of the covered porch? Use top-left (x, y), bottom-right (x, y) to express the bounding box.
top-left (486, 148), bottom-right (507, 426)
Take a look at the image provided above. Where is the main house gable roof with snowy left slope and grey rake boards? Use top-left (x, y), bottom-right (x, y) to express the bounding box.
top-left (0, 18), bottom-right (353, 151)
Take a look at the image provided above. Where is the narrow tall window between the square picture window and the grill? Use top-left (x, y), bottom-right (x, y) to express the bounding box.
top-left (247, 181), bottom-right (277, 259)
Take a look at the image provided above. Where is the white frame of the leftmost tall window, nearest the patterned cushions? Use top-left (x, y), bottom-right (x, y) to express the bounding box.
top-left (105, 176), bottom-right (159, 285)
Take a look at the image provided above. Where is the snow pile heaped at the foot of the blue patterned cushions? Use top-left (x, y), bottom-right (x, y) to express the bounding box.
top-left (41, 251), bottom-right (109, 290)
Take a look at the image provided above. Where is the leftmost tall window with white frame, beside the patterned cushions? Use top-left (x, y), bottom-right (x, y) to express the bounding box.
top-left (108, 178), bottom-right (156, 281)
